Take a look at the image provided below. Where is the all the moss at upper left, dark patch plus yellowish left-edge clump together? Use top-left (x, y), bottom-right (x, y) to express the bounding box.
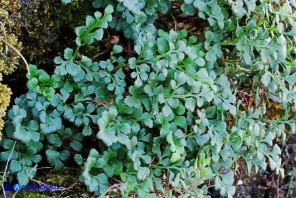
top-left (0, 0), bottom-right (92, 138)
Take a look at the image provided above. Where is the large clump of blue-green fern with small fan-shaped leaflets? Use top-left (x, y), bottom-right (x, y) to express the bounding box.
top-left (1, 0), bottom-right (296, 197)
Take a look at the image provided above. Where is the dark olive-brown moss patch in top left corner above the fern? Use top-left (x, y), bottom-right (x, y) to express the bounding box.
top-left (9, 0), bottom-right (92, 68)
